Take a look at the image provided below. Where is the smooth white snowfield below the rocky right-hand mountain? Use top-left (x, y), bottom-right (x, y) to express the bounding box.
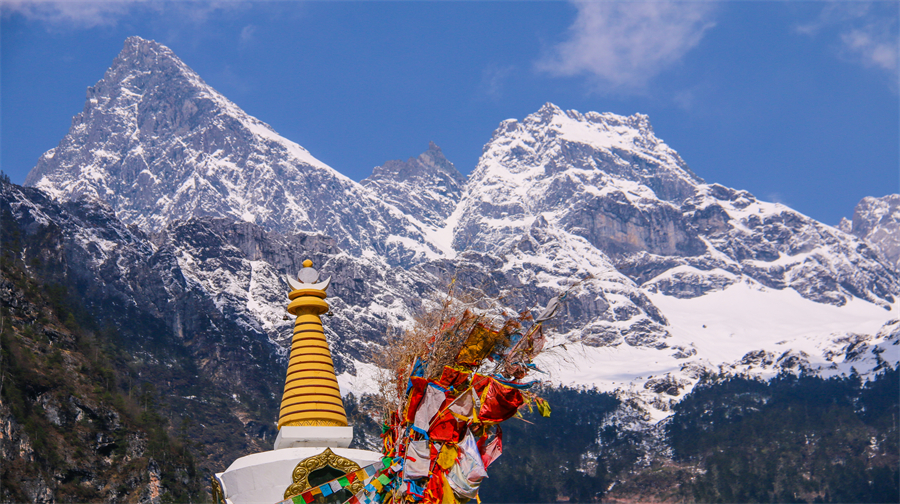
top-left (540, 280), bottom-right (900, 420)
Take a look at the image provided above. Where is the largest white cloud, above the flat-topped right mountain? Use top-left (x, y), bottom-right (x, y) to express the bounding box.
top-left (536, 1), bottom-right (715, 90)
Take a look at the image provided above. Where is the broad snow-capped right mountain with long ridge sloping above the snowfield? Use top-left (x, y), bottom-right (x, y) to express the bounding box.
top-left (454, 104), bottom-right (897, 306)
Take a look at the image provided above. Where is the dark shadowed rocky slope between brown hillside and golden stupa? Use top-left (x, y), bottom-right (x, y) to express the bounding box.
top-left (0, 184), bottom-right (294, 471)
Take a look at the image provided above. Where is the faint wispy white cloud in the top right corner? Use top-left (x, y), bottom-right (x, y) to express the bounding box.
top-left (796, 2), bottom-right (900, 79)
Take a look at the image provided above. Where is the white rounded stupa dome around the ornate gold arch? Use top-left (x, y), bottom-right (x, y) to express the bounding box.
top-left (216, 444), bottom-right (381, 504)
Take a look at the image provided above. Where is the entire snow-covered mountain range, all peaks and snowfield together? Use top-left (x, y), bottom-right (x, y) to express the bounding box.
top-left (16, 37), bottom-right (900, 426)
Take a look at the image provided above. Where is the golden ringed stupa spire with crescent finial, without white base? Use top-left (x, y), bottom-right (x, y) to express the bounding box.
top-left (278, 259), bottom-right (347, 430)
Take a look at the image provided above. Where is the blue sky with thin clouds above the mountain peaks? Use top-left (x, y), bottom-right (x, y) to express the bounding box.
top-left (0, 0), bottom-right (900, 224)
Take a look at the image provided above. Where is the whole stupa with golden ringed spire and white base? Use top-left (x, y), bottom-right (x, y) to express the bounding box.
top-left (213, 260), bottom-right (381, 504)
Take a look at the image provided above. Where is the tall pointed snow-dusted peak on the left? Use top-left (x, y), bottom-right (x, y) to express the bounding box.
top-left (26, 37), bottom-right (439, 263)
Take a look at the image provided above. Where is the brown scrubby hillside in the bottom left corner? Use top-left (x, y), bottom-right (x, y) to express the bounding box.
top-left (0, 236), bottom-right (202, 504)
